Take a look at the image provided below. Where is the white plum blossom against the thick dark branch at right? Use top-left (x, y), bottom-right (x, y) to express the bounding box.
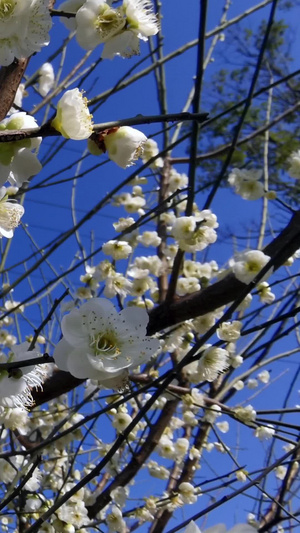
top-left (231, 250), bottom-right (273, 284)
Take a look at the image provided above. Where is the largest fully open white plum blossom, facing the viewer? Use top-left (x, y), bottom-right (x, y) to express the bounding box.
top-left (53, 298), bottom-right (160, 382)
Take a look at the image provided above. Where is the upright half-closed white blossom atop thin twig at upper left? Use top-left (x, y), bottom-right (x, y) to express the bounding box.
top-left (51, 89), bottom-right (93, 141)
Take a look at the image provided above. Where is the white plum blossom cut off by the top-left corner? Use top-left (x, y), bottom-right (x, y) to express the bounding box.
top-left (0, 0), bottom-right (52, 66)
